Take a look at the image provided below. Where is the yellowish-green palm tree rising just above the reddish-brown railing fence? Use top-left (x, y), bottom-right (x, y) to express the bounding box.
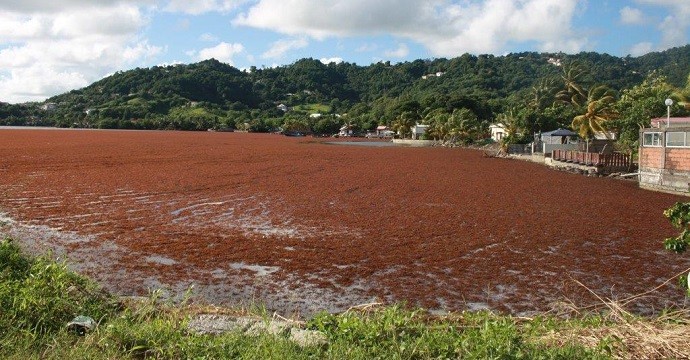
top-left (571, 85), bottom-right (618, 146)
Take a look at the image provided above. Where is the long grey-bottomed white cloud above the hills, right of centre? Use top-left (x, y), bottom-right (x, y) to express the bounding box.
top-left (233, 0), bottom-right (587, 56)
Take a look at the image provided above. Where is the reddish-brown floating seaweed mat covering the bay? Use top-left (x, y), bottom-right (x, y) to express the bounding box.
top-left (0, 129), bottom-right (690, 313)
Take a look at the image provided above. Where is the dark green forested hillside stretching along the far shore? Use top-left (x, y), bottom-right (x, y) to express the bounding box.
top-left (0, 45), bottom-right (690, 141)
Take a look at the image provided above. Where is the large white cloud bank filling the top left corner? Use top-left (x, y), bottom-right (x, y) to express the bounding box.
top-left (0, 0), bottom-right (164, 102)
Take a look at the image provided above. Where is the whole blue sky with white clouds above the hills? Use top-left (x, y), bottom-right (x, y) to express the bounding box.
top-left (0, 0), bottom-right (690, 103)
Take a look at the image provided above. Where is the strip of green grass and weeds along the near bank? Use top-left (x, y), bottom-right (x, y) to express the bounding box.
top-left (0, 239), bottom-right (690, 359)
